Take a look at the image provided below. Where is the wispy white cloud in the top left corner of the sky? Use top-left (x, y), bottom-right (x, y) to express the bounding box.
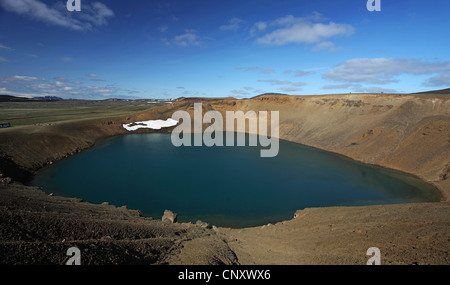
top-left (0, 0), bottom-right (114, 30)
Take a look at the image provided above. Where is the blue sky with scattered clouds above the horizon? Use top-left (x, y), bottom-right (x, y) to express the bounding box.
top-left (0, 0), bottom-right (450, 99)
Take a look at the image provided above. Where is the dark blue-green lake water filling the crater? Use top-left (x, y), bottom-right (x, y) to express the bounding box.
top-left (33, 134), bottom-right (440, 227)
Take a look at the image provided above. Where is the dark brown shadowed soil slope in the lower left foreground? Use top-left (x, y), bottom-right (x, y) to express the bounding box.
top-left (0, 183), bottom-right (237, 265)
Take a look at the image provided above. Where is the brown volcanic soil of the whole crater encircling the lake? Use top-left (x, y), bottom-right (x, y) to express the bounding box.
top-left (0, 94), bottom-right (450, 264)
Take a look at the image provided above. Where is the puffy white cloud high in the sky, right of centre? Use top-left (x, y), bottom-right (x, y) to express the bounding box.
top-left (250, 13), bottom-right (354, 46)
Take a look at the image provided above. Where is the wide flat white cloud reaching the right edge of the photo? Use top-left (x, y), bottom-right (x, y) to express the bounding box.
top-left (322, 58), bottom-right (450, 84)
